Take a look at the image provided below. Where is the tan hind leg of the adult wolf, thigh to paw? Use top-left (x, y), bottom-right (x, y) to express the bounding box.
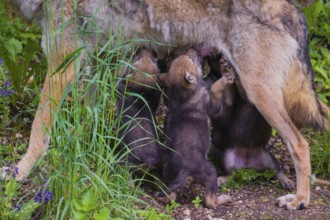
top-left (240, 74), bottom-right (311, 209)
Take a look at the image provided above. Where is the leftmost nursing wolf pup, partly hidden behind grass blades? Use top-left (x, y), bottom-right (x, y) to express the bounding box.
top-left (117, 48), bottom-right (161, 166)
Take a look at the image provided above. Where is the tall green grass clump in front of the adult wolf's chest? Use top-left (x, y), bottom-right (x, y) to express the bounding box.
top-left (30, 1), bottom-right (162, 219)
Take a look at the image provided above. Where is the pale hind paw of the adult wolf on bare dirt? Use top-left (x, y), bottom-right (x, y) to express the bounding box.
top-left (276, 194), bottom-right (309, 210)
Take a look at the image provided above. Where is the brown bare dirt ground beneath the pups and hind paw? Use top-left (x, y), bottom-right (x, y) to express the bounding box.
top-left (143, 139), bottom-right (330, 220)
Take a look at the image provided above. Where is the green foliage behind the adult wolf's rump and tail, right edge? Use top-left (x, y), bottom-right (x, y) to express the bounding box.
top-left (303, 0), bottom-right (330, 178)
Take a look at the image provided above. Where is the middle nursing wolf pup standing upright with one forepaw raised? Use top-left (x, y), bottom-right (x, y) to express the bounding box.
top-left (157, 49), bottom-right (235, 208)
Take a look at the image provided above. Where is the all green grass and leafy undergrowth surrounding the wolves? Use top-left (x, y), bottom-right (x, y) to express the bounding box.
top-left (0, 0), bottom-right (330, 219)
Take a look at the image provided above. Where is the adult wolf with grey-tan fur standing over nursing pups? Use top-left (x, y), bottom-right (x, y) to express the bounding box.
top-left (6, 0), bottom-right (329, 209)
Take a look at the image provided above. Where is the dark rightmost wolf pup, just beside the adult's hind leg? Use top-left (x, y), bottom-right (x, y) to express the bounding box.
top-left (206, 57), bottom-right (294, 190)
